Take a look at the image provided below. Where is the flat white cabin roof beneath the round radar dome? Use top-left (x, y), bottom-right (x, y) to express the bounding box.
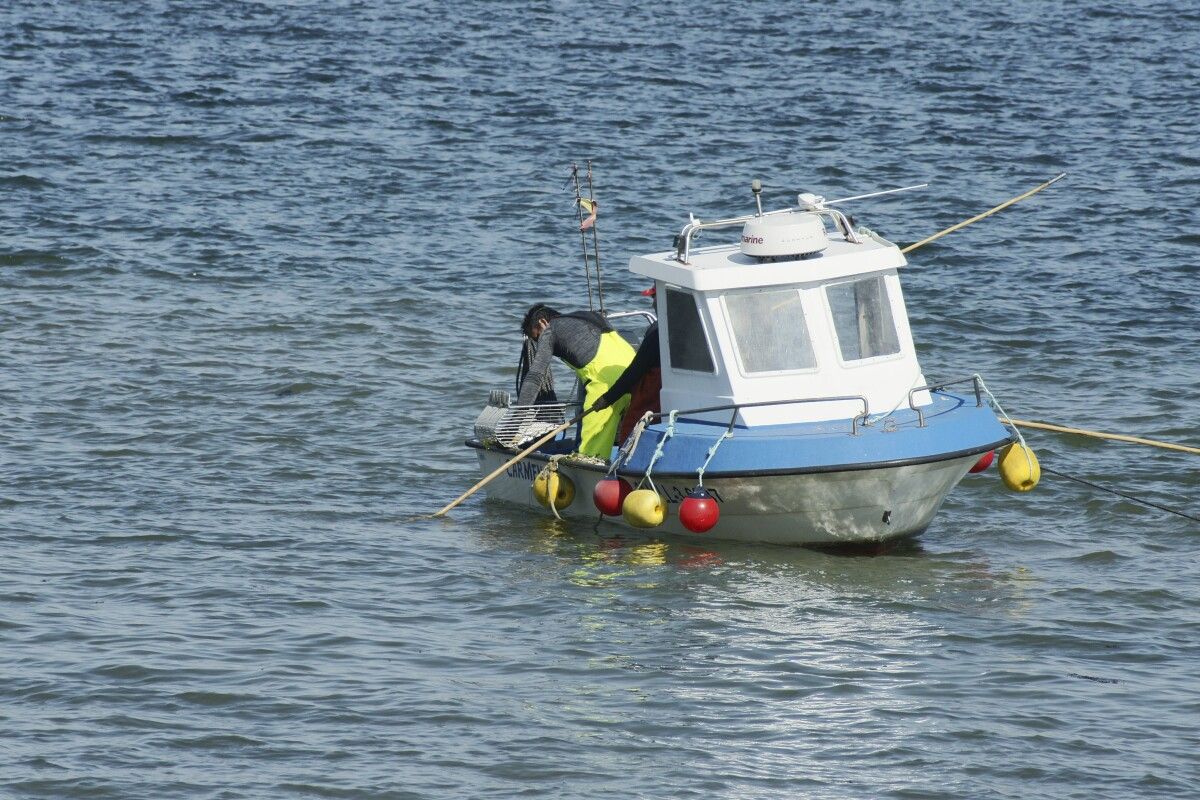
top-left (629, 230), bottom-right (907, 291)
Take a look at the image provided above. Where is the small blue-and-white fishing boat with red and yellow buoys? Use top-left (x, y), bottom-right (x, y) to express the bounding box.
top-left (466, 181), bottom-right (1037, 545)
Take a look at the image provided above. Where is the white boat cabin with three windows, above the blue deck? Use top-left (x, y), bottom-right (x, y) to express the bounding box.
top-left (630, 196), bottom-right (930, 426)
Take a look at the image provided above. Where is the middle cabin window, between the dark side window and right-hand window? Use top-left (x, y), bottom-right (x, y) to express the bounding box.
top-left (725, 289), bottom-right (817, 373)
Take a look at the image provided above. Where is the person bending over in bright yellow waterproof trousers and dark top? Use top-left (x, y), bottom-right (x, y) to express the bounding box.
top-left (517, 303), bottom-right (634, 461)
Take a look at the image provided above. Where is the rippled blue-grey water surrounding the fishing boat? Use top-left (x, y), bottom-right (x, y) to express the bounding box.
top-left (0, 0), bottom-right (1200, 800)
